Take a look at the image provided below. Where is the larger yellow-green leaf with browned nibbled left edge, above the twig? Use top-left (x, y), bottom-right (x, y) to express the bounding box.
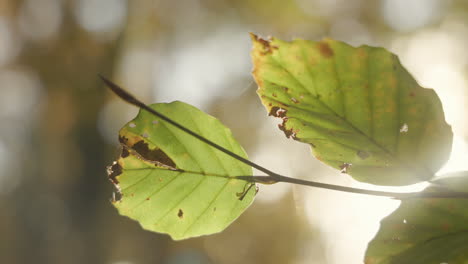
top-left (252, 35), bottom-right (452, 185)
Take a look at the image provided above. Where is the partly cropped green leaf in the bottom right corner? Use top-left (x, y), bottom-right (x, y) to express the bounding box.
top-left (365, 172), bottom-right (468, 264)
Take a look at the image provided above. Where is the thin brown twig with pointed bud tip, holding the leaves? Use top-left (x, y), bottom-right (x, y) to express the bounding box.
top-left (99, 75), bottom-right (468, 200)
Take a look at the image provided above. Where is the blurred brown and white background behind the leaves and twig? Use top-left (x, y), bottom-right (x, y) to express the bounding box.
top-left (0, 0), bottom-right (468, 264)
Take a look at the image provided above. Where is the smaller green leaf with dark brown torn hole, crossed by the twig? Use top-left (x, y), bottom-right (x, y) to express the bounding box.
top-left (109, 102), bottom-right (256, 240)
